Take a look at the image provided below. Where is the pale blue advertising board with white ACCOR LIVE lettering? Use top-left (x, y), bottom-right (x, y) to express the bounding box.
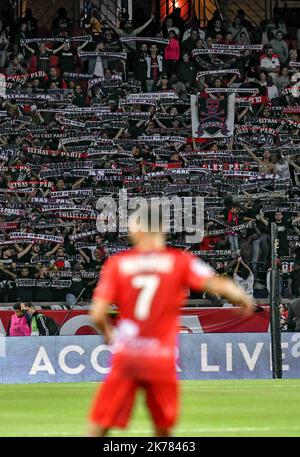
top-left (0, 333), bottom-right (300, 384)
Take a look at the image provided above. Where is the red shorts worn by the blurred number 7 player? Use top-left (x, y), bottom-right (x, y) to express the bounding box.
top-left (90, 375), bottom-right (178, 428)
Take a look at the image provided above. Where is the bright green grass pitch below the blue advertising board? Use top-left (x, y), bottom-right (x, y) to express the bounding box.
top-left (0, 379), bottom-right (300, 437)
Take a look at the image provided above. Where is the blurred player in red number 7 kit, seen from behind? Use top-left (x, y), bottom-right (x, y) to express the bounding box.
top-left (88, 208), bottom-right (254, 437)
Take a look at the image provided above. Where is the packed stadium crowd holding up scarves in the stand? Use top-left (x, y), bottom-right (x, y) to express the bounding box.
top-left (0, 3), bottom-right (300, 303)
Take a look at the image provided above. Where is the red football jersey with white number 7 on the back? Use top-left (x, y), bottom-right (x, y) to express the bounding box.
top-left (93, 248), bottom-right (214, 377)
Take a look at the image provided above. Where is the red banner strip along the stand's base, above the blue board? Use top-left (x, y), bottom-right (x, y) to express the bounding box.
top-left (0, 306), bottom-right (270, 335)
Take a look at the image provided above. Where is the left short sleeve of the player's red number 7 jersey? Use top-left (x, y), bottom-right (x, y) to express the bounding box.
top-left (93, 257), bottom-right (118, 303)
